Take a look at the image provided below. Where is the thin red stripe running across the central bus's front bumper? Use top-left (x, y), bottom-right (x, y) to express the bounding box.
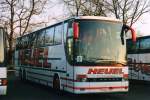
top-left (63, 85), bottom-right (128, 90)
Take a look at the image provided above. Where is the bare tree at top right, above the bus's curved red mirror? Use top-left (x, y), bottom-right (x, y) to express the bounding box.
top-left (105, 0), bottom-right (150, 26)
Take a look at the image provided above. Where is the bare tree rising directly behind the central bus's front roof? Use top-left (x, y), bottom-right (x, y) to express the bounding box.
top-left (63, 0), bottom-right (106, 16)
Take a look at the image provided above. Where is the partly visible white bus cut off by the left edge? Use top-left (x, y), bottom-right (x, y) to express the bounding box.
top-left (0, 27), bottom-right (7, 95)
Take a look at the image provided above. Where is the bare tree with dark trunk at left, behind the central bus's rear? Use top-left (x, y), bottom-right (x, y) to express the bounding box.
top-left (0, 0), bottom-right (47, 63)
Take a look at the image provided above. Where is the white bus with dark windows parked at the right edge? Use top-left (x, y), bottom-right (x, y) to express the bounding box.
top-left (127, 36), bottom-right (150, 81)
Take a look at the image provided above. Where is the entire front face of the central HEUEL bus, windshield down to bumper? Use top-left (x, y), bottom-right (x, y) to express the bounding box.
top-left (67, 19), bottom-right (128, 93)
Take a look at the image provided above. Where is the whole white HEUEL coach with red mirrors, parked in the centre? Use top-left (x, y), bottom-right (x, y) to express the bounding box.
top-left (15, 16), bottom-right (135, 94)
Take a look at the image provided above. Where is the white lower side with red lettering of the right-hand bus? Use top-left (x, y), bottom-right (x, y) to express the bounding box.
top-left (128, 53), bottom-right (150, 81)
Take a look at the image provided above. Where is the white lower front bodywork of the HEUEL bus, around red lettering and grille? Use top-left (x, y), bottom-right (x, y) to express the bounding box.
top-left (64, 66), bottom-right (129, 94)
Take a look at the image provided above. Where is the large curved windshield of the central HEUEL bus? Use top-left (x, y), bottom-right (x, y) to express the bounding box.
top-left (74, 20), bottom-right (126, 65)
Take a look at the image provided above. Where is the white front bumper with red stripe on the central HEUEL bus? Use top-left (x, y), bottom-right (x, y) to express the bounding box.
top-left (73, 82), bottom-right (128, 94)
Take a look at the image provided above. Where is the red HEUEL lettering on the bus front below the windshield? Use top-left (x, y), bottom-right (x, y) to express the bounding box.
top-left (88, 68), bottom-right (123, 74)
